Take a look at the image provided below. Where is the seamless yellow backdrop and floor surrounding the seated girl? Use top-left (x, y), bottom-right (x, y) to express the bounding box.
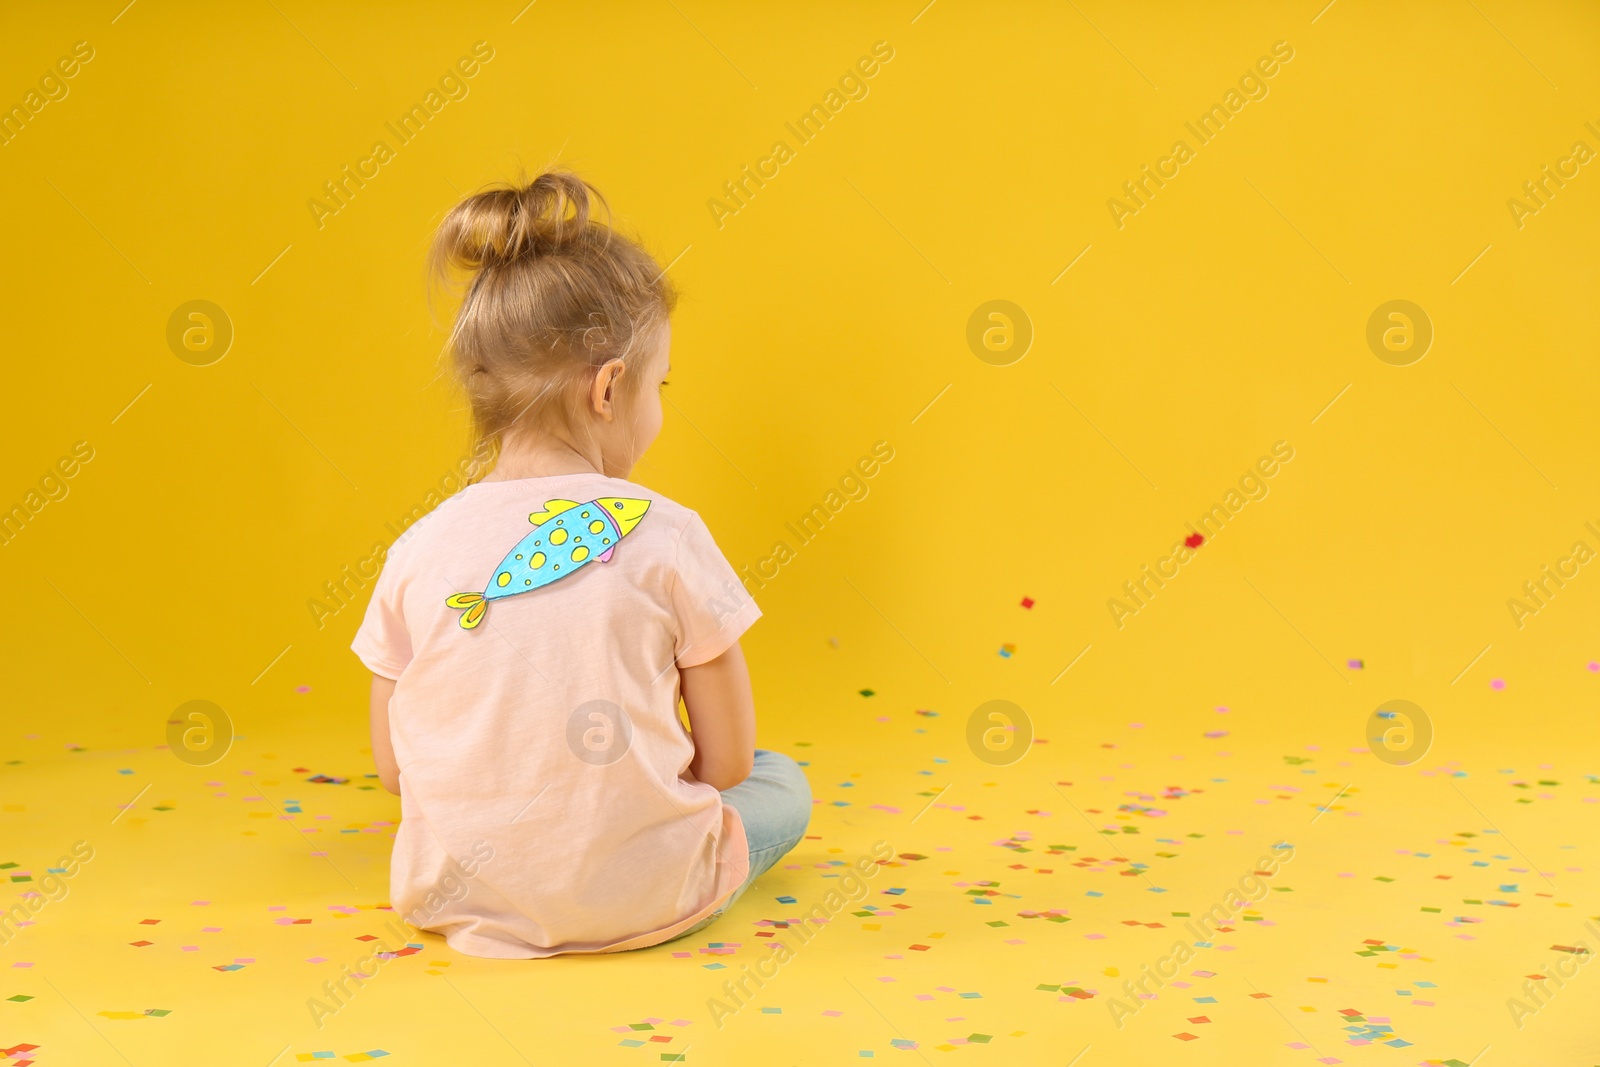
top-left (0, 0), bottom-right (1600, 1067)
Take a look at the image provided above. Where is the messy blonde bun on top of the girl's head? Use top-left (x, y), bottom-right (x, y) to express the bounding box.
top-left (435, 171), bottom-right (608, 270)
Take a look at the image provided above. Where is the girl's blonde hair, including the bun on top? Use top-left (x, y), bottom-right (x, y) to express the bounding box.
top-left (429, 171), bottom-right (677, 470)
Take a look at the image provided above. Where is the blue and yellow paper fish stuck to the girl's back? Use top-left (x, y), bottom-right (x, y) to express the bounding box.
top-left (445, 496), bottom-right (650, 630)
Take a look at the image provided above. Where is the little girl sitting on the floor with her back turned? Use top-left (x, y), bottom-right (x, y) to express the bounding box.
top-left (354, 173), bottom-right (811, 958)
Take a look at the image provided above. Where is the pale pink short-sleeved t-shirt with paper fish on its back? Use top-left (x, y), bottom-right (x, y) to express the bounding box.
top-left (352, 474), bottom-right (760, 958)
